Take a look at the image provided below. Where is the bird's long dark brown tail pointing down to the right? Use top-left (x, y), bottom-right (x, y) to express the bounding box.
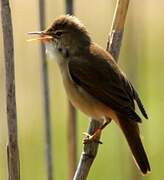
top-left (118, 115), bottom-right (150, 174)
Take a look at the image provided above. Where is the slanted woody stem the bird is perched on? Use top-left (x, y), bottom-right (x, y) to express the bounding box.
top-left (74, 0), bottom-right (129, 180)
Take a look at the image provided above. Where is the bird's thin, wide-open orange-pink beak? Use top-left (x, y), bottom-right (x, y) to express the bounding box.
top-left (27, 31), bottom-right (53, 42)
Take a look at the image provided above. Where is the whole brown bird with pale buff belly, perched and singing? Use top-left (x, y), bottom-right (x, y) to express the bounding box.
top-left (27, 15), bottom-right (150, 174)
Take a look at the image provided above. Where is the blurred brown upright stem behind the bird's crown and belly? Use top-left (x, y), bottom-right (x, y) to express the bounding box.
top-left (65, 0), bottom-right (77, 180)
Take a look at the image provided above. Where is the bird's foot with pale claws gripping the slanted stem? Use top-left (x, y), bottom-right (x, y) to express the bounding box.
top-left (83, 129), bottom-right (102, 144)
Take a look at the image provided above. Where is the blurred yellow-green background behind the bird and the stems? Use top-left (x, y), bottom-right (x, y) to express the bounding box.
top-left (0, 0), bottom-right (164, 180)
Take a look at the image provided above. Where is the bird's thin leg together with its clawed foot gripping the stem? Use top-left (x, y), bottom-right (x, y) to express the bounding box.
top-left (83, 118), bottom-right (111, 144)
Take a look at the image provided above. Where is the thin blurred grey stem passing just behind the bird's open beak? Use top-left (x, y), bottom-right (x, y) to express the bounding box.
top-left (39, 0), bottom-right (53, 180)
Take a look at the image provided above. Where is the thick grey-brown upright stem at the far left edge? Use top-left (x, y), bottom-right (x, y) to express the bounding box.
top-left (1, 0), bottom-right (20, 180)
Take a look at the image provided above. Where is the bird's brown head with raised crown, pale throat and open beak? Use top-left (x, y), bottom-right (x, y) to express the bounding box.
top-left (29, 15), bottom-right (91, 54)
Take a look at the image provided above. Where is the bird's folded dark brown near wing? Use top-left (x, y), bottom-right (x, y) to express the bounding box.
top-left (68, 46), bottom-right (144, 122)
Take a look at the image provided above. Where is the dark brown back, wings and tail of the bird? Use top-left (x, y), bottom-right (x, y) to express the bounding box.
top-left (69, 42), bottom-right (150, 174)
